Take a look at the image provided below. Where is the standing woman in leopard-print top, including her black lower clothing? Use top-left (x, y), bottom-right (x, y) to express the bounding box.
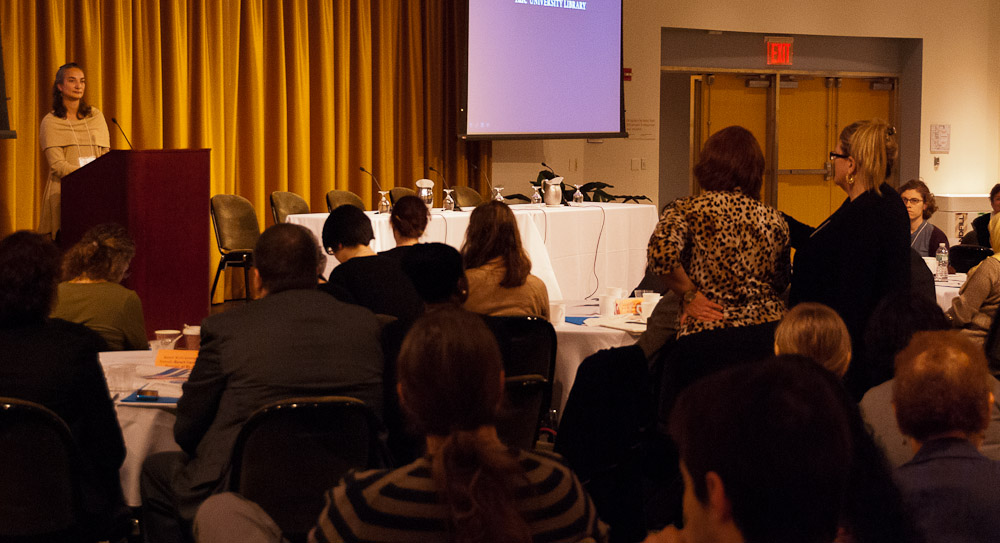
top-left (646, 126), bottom-right (789, 436)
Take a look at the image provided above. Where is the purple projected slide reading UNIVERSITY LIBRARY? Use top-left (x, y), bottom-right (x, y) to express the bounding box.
top-left (466, 0), bottom-right (621, 135)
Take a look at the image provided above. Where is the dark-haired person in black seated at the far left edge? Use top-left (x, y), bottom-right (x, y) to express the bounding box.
top-left (0, 231), bottom-right (130, 541)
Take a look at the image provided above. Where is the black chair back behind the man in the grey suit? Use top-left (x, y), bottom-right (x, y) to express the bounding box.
top-left (229, 396), bottom-right (391, 541)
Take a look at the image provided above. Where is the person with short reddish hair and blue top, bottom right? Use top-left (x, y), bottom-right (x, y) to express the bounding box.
top-left (893, 332), bottom-right (1000, 541)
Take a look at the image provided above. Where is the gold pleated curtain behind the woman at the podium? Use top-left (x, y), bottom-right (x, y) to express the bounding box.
top-left (0, 0), bottom-right (490, 297)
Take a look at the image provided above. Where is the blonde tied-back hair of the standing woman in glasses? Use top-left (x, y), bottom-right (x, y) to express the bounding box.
top-left (840, 119), bottom-right (899, 196)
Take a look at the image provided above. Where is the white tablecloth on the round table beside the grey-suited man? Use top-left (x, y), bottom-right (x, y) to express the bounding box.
top-left (101, 351), bottom-right (180, 507)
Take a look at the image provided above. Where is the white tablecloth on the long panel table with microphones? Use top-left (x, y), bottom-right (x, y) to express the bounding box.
top-left (287, 203), bottom-right (657, 300)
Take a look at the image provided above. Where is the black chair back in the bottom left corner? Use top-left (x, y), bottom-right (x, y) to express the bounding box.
top-left (0, 397), bottom-right (80, 541)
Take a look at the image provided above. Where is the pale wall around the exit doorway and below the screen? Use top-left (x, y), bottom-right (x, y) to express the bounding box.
top-left (493, 0), bottom-right (1000, 201)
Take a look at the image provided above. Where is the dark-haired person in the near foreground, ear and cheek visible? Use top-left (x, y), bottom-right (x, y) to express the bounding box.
top-left (646, 358), bottom-right (851, 543)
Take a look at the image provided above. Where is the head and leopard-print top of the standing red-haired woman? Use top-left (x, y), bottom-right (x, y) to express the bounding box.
top-left (647, 126), bottom-right (790, 337)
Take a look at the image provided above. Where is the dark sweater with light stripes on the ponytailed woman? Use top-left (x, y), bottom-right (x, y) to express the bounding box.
top-left (309, 451), bottom-right (607, 543)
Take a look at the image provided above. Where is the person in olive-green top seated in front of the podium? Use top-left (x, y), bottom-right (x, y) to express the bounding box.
top-left (52, 224), bottom-right (149, 351)
